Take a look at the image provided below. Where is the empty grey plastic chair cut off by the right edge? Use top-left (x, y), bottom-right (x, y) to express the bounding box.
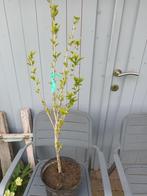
top-left (114, 114), bottom-right (147, 196)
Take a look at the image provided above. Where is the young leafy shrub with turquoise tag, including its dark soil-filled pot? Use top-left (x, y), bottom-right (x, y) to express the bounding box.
top-left (27, 0), bottom-right (83, 195)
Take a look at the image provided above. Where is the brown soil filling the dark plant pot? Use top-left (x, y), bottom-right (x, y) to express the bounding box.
top-left (42, 158), bottom-right (81, 190)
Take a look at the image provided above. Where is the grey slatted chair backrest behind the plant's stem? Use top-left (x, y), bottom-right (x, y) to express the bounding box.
top-left (33, 111), bottom-right (92, 162)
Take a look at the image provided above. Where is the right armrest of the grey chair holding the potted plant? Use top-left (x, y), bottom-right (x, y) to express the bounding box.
top-left (92, 145), bottom-right (112, 196)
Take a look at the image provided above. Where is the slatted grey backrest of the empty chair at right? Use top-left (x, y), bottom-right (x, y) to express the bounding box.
top-left (121, 114), bottom-right (147, 163)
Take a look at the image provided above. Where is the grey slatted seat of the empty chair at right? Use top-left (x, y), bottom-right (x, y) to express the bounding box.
top-left (125, 164), bottom-right (147, 196)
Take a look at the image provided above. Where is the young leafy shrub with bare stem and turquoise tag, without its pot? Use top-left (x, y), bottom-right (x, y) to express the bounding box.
top-left (27, 0), bottom-right (83, 173)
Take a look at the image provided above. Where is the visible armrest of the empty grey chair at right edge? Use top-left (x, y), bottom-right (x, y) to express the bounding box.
top-left (114, 152), bottom-right (133, 196)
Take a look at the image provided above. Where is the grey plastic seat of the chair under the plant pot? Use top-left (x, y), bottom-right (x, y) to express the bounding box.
top-left (24, 161), bottom-right (92, 196)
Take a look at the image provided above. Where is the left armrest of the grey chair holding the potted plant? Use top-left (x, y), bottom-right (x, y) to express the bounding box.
top-left (0, 142), bottom-right (32, 196)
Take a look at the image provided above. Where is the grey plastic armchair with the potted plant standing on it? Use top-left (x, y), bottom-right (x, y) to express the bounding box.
top-left (0, 111), bottom-right (112, 196)
